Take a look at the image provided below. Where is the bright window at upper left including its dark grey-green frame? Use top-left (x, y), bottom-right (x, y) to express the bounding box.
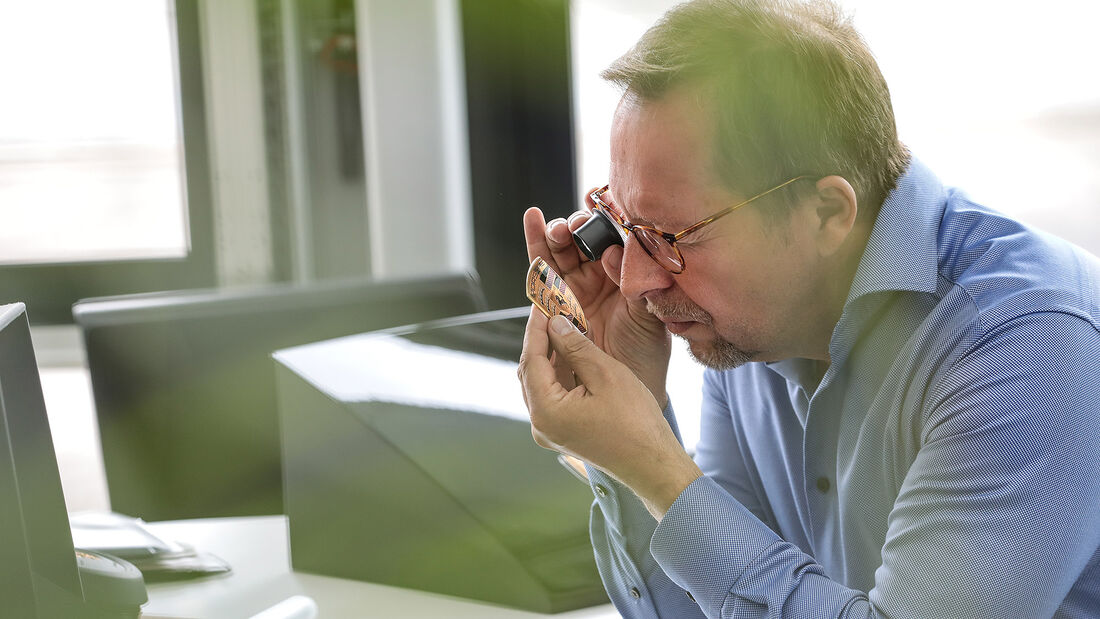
top-left (0, 0), bottom-right (213, 323)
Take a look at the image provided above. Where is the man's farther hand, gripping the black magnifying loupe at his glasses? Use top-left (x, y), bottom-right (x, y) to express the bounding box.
top-left (524, 201), bottom-right (672, 409)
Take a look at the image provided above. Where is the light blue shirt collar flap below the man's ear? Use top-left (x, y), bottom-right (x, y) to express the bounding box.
top-left (847, 158), bottom-right (947, 303)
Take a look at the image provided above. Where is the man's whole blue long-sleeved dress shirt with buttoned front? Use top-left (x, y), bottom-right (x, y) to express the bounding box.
top-left (589, 162), bottom-right (1100, 619)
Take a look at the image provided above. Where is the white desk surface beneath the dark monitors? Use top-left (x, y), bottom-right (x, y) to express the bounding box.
top-left (142, 516), bottom-right (618, 619)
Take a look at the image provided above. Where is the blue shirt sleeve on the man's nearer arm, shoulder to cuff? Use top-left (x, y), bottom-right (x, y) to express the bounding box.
top-left (642, 312), bottom-right (1100, 619)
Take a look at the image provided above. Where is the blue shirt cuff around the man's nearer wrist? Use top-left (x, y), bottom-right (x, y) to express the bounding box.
top-left (649, 475), bottom-right (782, 615)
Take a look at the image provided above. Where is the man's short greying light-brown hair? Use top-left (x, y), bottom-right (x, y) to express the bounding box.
top-left (601, 0), bottom-right (910, 218)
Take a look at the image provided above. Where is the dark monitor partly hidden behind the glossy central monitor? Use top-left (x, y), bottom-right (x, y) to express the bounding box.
top-left (73, 275), bottom-right (485, 521)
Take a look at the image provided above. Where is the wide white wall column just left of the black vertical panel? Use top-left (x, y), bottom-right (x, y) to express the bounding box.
top-left (355, 0), bottom-right (474, 278)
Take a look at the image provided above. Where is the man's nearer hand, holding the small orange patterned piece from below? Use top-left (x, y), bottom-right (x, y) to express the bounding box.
top-left (518, 308), bottom-right (703, 520)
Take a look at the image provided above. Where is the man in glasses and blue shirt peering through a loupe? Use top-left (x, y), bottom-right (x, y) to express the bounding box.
top-left (519, 0), bottom-right (1100, 618)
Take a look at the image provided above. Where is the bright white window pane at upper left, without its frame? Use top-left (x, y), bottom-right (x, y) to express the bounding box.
top-left (0, 0), bottom-right (188, 264)
